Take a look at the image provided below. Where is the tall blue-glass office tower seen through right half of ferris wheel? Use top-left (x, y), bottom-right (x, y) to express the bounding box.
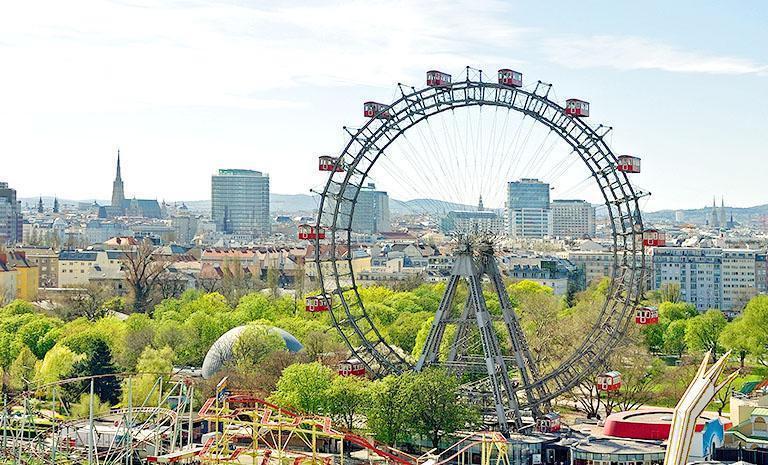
top-left (507, 179), bottom-right (552, 239)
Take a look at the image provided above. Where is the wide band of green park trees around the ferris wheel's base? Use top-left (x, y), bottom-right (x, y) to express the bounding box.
top-left (0, 280), bottom-right (768, 440)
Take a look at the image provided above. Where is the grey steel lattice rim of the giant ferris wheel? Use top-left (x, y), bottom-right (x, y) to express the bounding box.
top-left (314, 70), bottom-right (644, 405)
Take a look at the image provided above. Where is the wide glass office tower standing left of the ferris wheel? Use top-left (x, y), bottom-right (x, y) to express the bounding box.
top-left (211, 169), bottom-right (271, 236)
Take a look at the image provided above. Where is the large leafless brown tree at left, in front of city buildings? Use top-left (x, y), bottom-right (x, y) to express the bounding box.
top-left (123, 239), bottom-right (171, 313)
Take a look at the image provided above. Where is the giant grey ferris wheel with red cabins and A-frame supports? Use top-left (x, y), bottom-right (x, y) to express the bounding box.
top-left (299, 64), bottom-right (664, 432)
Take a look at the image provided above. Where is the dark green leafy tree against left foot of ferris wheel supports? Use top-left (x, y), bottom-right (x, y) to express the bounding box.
top-left (408, 368), bottom-right (479, 448)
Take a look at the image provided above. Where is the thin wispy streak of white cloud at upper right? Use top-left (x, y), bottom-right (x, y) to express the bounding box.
top-left (544, 35), bottom-right (768, 74)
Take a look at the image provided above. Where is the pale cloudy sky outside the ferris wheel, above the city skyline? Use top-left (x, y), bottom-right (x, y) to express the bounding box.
top-left (0, 0), bottom-right (768, 210)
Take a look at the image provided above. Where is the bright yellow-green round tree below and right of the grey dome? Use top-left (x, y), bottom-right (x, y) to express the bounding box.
top-left (270, 362), bottom-right (334, 415)
